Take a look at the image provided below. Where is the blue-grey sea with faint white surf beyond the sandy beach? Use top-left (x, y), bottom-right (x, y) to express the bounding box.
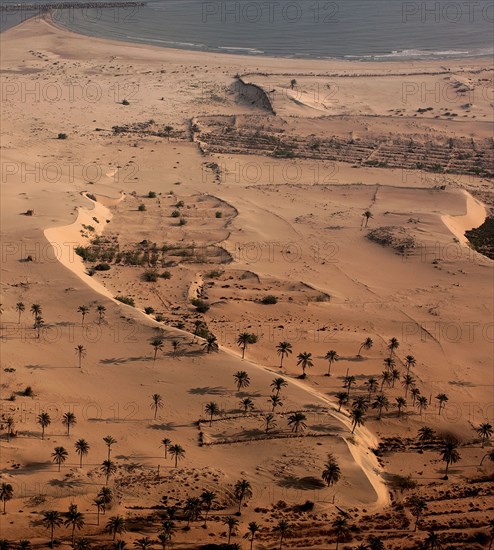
top-left (0, 0), bottom-right (494, 60)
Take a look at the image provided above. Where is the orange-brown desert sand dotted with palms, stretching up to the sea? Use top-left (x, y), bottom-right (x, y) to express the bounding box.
top-left (0, 19), bottom-right (494, 549)
